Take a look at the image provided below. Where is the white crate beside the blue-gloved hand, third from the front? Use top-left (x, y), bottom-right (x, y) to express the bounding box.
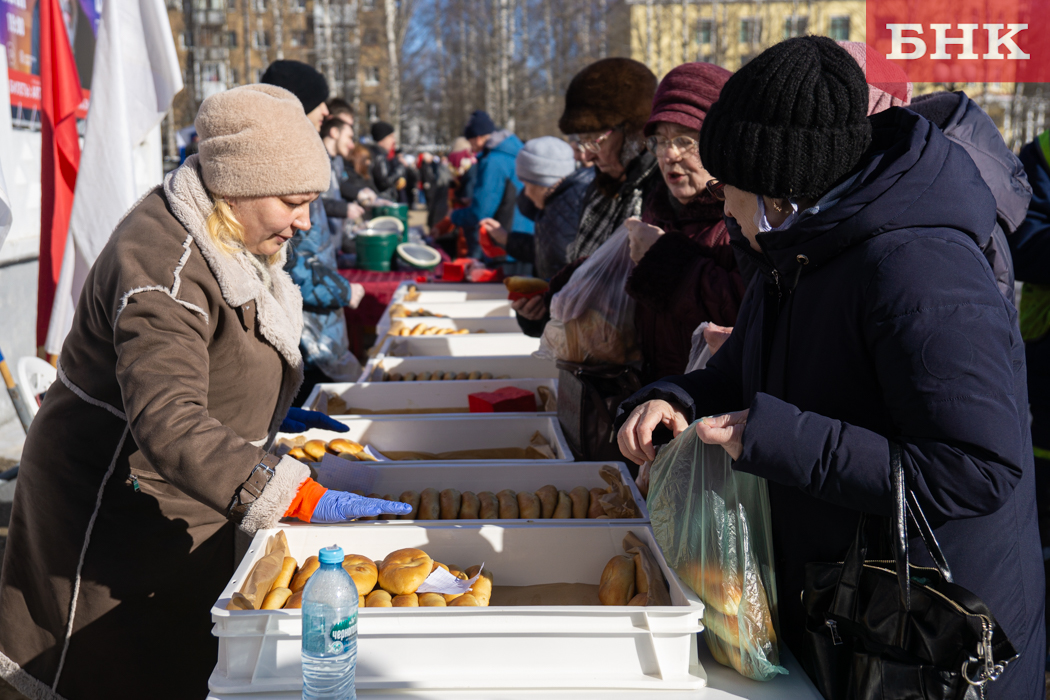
top-left (277, 413), bottom-right (572, 465)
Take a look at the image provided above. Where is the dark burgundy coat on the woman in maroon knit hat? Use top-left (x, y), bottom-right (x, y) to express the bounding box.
top-left (627, 181), bottom-right (744, 382)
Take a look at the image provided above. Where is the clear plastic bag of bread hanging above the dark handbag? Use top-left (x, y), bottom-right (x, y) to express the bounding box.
top-left (537, 225), bottom-right (642, 364)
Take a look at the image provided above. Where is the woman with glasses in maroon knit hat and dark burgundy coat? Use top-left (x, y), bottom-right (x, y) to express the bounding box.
top-left (627, 63), bottom-right (744, 382)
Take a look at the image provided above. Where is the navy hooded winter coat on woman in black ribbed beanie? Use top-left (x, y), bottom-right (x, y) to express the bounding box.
top-left (620, 108), bottom-right (1045, 700)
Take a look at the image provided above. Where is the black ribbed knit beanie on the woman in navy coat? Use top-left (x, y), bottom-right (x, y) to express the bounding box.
top-left (700, 37), bottom-right (872, 197)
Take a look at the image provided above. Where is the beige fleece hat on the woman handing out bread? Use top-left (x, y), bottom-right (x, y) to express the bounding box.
top-left (193, 85), bottom-right (332, 197)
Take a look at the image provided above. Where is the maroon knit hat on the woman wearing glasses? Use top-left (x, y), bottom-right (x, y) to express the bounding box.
top-left (645, 62), bottom-right (733, 136)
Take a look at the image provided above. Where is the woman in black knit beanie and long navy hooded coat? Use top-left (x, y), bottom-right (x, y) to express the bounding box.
top-left (618, 37), bottom-right (1045, 700)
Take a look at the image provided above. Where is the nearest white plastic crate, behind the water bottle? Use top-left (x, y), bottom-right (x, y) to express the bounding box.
top-left (209, 524), bottom-right (705, 697)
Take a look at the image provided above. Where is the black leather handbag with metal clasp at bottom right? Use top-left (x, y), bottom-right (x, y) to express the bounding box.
top-left (802, 442), bottom-right (1017, 700)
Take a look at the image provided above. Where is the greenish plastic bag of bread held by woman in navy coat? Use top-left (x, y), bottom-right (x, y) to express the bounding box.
top-left (647, 423), bottom-right (788, 680)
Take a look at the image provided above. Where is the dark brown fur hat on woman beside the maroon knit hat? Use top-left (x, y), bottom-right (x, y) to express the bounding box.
top-left (558, 58), bottom-right (656, 134)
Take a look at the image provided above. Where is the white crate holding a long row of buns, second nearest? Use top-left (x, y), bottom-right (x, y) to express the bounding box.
top-left (282, 460), bottom-right (649, 528)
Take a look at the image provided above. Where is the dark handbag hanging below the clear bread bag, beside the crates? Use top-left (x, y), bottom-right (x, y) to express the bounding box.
top-left (558, 360), bottom-right (642, 475)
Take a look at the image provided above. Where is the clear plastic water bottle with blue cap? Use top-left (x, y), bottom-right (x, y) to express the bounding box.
top-left (302, 545), bottom-right (357, 700)
